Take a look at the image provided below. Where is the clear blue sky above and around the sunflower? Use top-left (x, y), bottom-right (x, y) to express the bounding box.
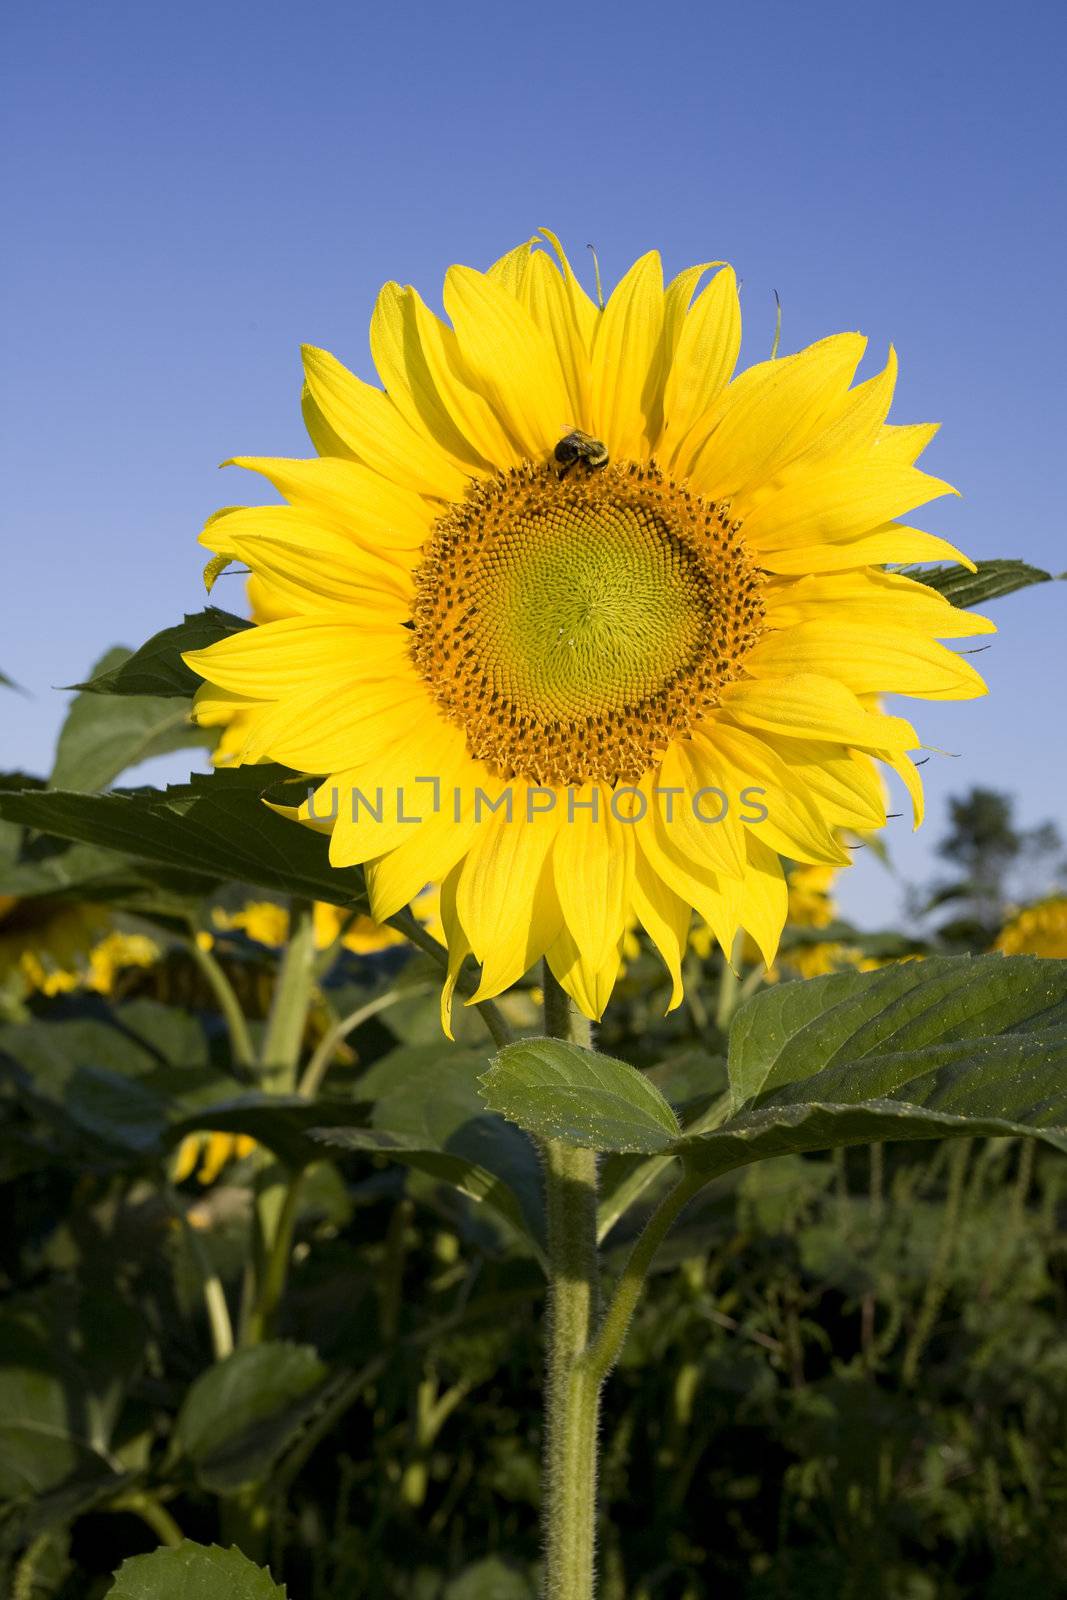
top-left (0, 0), bottom-right (1067, 923)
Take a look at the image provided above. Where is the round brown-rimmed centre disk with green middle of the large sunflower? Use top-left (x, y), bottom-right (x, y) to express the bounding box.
top-left (413, 466), bottom-right (763, 784)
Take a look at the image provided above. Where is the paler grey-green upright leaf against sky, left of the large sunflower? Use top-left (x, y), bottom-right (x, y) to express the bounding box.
top-left (48, 648), bottom-right (218, 790)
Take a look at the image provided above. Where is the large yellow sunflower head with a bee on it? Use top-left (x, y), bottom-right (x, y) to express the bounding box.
top-left (186, 232), bottom-right (992, 1018)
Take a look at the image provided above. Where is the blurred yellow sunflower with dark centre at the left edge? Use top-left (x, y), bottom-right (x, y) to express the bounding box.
top-left (0, 896), bottom-right (162, 995)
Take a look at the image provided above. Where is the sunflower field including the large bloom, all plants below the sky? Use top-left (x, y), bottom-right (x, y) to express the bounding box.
top-left (0, 232), bottom-right (1067, 1600)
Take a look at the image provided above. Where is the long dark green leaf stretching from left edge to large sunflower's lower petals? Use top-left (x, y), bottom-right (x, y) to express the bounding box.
top-left (0, 766), bottom-right (366, 906)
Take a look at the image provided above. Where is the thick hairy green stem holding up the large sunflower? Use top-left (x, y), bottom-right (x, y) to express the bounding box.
top-left (542, 963), bottom-right (600, 1600)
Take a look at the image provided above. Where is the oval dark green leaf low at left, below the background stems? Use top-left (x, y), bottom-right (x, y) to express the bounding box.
top-left (174, 1339), bottom-right (326, 1494)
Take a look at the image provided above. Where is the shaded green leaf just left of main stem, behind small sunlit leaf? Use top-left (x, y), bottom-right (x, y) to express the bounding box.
top-left (320, 1045), bottom-right (545, 1259)
